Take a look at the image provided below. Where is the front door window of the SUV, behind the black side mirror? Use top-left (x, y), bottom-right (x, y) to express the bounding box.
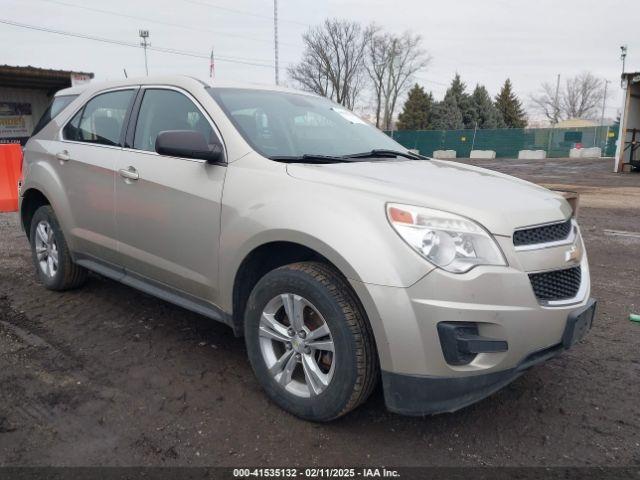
top-left (133, 89), bottom-right (220, 152)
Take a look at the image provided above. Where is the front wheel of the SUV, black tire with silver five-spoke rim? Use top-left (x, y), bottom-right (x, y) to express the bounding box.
top-left (244, 262), bottom-right (379, 422)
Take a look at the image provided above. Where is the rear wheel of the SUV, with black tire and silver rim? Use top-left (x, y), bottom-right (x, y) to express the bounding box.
top-left (29, 205), bottom-right (87, 291)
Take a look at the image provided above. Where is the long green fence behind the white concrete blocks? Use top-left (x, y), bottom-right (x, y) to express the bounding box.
top-left (387, 125), bottom-right (619, 158)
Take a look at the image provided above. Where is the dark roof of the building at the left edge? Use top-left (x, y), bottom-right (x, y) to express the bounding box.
top-left (0, 65), bottom-right (94, 91)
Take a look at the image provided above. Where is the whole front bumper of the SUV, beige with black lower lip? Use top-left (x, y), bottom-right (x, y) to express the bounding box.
top-left (352, 231), bottom-right (591, 414)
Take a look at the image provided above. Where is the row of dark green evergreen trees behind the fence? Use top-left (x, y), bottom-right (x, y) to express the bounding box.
top-left (397, 74), bottom-right (527, 130)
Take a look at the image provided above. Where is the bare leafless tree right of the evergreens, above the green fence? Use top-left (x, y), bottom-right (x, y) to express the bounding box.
top-left (531, 72), bottom-right (605, 124)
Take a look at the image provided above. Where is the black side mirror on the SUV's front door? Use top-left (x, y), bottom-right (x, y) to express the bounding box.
top-left (156, 130), bottom-right (224, 163)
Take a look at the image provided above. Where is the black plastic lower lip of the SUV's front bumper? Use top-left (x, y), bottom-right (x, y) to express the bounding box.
top-left (382, 299), bottom-right (596, 415)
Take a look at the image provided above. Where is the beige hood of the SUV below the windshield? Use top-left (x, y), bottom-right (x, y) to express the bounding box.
top-left (287, 160), bottom-right (571, 236)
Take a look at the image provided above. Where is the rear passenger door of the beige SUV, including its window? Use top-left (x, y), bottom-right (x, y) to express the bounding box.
top-left (57, 87), bottom-right (137, 263)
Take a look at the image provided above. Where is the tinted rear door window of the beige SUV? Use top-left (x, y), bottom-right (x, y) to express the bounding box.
top-left (63, 90), bottom-right (134, 145)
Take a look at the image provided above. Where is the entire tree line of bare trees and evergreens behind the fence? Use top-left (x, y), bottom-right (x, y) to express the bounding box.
top-left (288, 18), bottom-right (606, 130)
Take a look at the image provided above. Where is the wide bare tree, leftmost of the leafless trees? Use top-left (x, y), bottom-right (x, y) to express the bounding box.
top-left (288, 19), bottom-right (371, 109)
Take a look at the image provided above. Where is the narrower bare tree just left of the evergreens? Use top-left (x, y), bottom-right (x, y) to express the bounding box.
top-left (366, 31), bottom-right (430, 130)
